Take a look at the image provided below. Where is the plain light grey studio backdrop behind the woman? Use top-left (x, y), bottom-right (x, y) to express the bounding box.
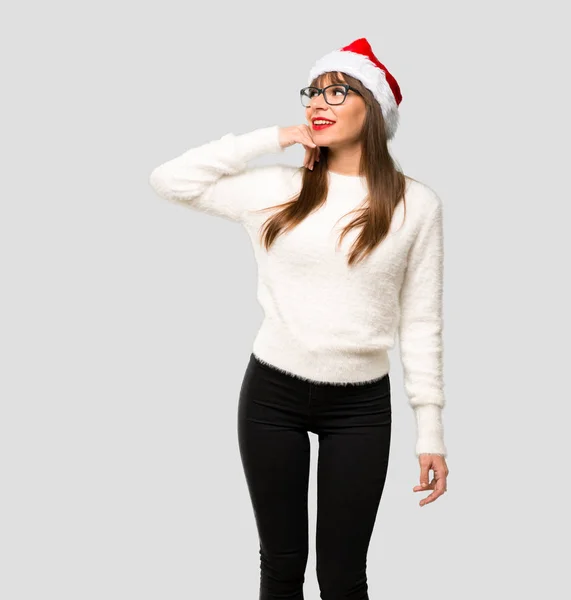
top-left (0, 1), bottom-right (571, 600)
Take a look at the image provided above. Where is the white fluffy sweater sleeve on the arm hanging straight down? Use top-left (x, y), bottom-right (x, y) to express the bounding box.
top-left (399, 195), bottom-right (447, 456)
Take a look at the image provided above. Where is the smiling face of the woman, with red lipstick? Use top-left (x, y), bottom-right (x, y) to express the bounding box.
top-left (305, 76), bottom-right (367, 148)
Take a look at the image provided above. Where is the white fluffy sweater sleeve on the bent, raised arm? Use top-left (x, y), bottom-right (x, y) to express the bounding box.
top-left (149, 125), bottom-right (284, 222)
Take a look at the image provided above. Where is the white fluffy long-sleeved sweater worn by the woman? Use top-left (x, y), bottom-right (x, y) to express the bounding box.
top-left (149, 125), bottom-right (447, 456)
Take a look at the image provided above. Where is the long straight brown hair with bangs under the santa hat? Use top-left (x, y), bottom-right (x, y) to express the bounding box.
top-left (260, 72), bottom-right (406, 265)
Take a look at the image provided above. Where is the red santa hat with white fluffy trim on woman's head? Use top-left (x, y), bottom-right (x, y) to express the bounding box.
top-left (308, 38), bottom-right (402, 140)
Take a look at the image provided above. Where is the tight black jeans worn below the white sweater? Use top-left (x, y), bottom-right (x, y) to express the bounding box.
top-left (238, 354), bottom-right (392, 600)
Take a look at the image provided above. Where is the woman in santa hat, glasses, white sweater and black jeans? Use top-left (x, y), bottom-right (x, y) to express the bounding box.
top-left (150, 38), bottom-right (448, 600)
